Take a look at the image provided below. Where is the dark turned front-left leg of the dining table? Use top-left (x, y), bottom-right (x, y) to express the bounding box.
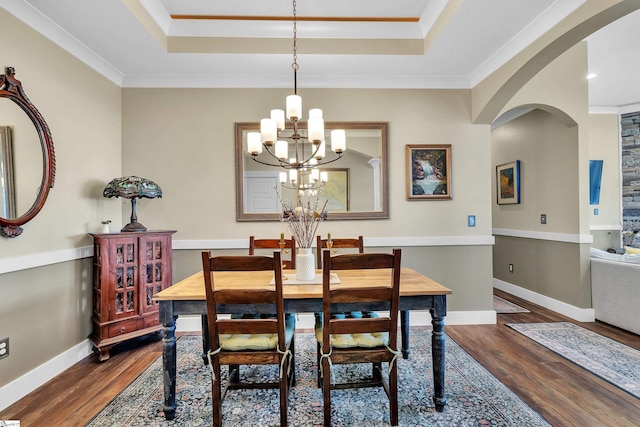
top-left (160, 301), bottom-right (178, 420)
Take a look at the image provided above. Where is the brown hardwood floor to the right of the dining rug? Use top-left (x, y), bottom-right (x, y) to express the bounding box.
top-left (445, 290), bottom-right (640, 426)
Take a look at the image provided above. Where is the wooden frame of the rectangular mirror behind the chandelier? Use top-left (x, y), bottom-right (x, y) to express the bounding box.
top-left (235, 122), bottom-right (389, 222)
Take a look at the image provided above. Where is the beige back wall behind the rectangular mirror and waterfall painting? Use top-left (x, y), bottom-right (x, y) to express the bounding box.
top-left (122, 89), bottom-right (492, 310)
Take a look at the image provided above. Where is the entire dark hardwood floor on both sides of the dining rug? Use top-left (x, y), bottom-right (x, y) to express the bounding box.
top-left (0, 290), bottom-right (640, 427)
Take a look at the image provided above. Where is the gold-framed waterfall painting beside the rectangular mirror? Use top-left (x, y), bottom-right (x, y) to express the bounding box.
top-left (406, 144), bottom-right (451, 200)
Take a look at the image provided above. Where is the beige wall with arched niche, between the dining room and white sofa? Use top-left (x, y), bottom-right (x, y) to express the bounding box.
top-left (492, 43), bottom-right (591, 308)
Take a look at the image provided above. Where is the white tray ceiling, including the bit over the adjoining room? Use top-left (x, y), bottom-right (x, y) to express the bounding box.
top-left (5, 0), bottom-right (640, 112)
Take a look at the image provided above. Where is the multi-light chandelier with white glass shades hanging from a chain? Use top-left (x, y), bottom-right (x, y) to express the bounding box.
top-left (247, 0), bottom-right (346, 189)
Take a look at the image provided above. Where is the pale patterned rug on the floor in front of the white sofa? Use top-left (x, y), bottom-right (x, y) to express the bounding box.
top-left (507, 322), bottom-right (640, 398)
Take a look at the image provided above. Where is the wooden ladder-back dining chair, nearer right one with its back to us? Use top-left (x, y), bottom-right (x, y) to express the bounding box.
top-left (315, 249), bottom-right (401, 426)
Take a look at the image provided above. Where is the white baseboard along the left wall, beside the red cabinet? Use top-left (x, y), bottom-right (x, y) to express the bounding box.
top-left (0, 339), bottom-right (92, 411)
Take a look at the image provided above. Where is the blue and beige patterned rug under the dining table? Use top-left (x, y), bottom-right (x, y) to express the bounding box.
top-left (88, 330), bottom-right (549, 427)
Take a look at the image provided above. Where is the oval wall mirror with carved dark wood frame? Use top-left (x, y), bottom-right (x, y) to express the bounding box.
top-left (0, 67), bottom-right (55, 237)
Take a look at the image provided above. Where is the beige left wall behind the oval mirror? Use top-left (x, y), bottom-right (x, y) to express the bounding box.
top-left (0, 9), bottom-right (121, 386)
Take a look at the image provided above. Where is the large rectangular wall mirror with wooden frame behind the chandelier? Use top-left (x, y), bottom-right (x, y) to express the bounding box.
top-left (235, 122), bottom-right (389, 221)
